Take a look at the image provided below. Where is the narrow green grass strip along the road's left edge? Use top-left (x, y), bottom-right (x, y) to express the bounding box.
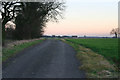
top-left (2, 39), bottom-right (44, 62)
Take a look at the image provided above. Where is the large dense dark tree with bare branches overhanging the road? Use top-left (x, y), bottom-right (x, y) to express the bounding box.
top-left (15, 1), bottom-right (64, 39)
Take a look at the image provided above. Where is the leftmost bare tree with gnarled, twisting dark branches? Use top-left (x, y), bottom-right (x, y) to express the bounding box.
top-left (0, 1), bottom-right (20, 45)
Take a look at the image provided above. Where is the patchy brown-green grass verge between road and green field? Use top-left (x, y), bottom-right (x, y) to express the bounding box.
top-left (62, 40), bottom-right (118, 78)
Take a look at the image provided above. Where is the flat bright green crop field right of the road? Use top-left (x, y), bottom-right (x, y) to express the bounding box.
top-left (66, 39), bottom-right (119, 63)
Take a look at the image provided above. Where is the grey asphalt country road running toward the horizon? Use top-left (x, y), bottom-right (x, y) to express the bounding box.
top-left (2, 39), bottom-right (85, 78)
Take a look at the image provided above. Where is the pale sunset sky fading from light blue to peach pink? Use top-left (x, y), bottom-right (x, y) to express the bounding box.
top-left (44, 0), bottom-right (119, 36)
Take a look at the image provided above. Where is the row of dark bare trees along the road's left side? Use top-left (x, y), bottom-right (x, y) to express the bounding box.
top-left (0, 0), bottom-right (65, 44)
